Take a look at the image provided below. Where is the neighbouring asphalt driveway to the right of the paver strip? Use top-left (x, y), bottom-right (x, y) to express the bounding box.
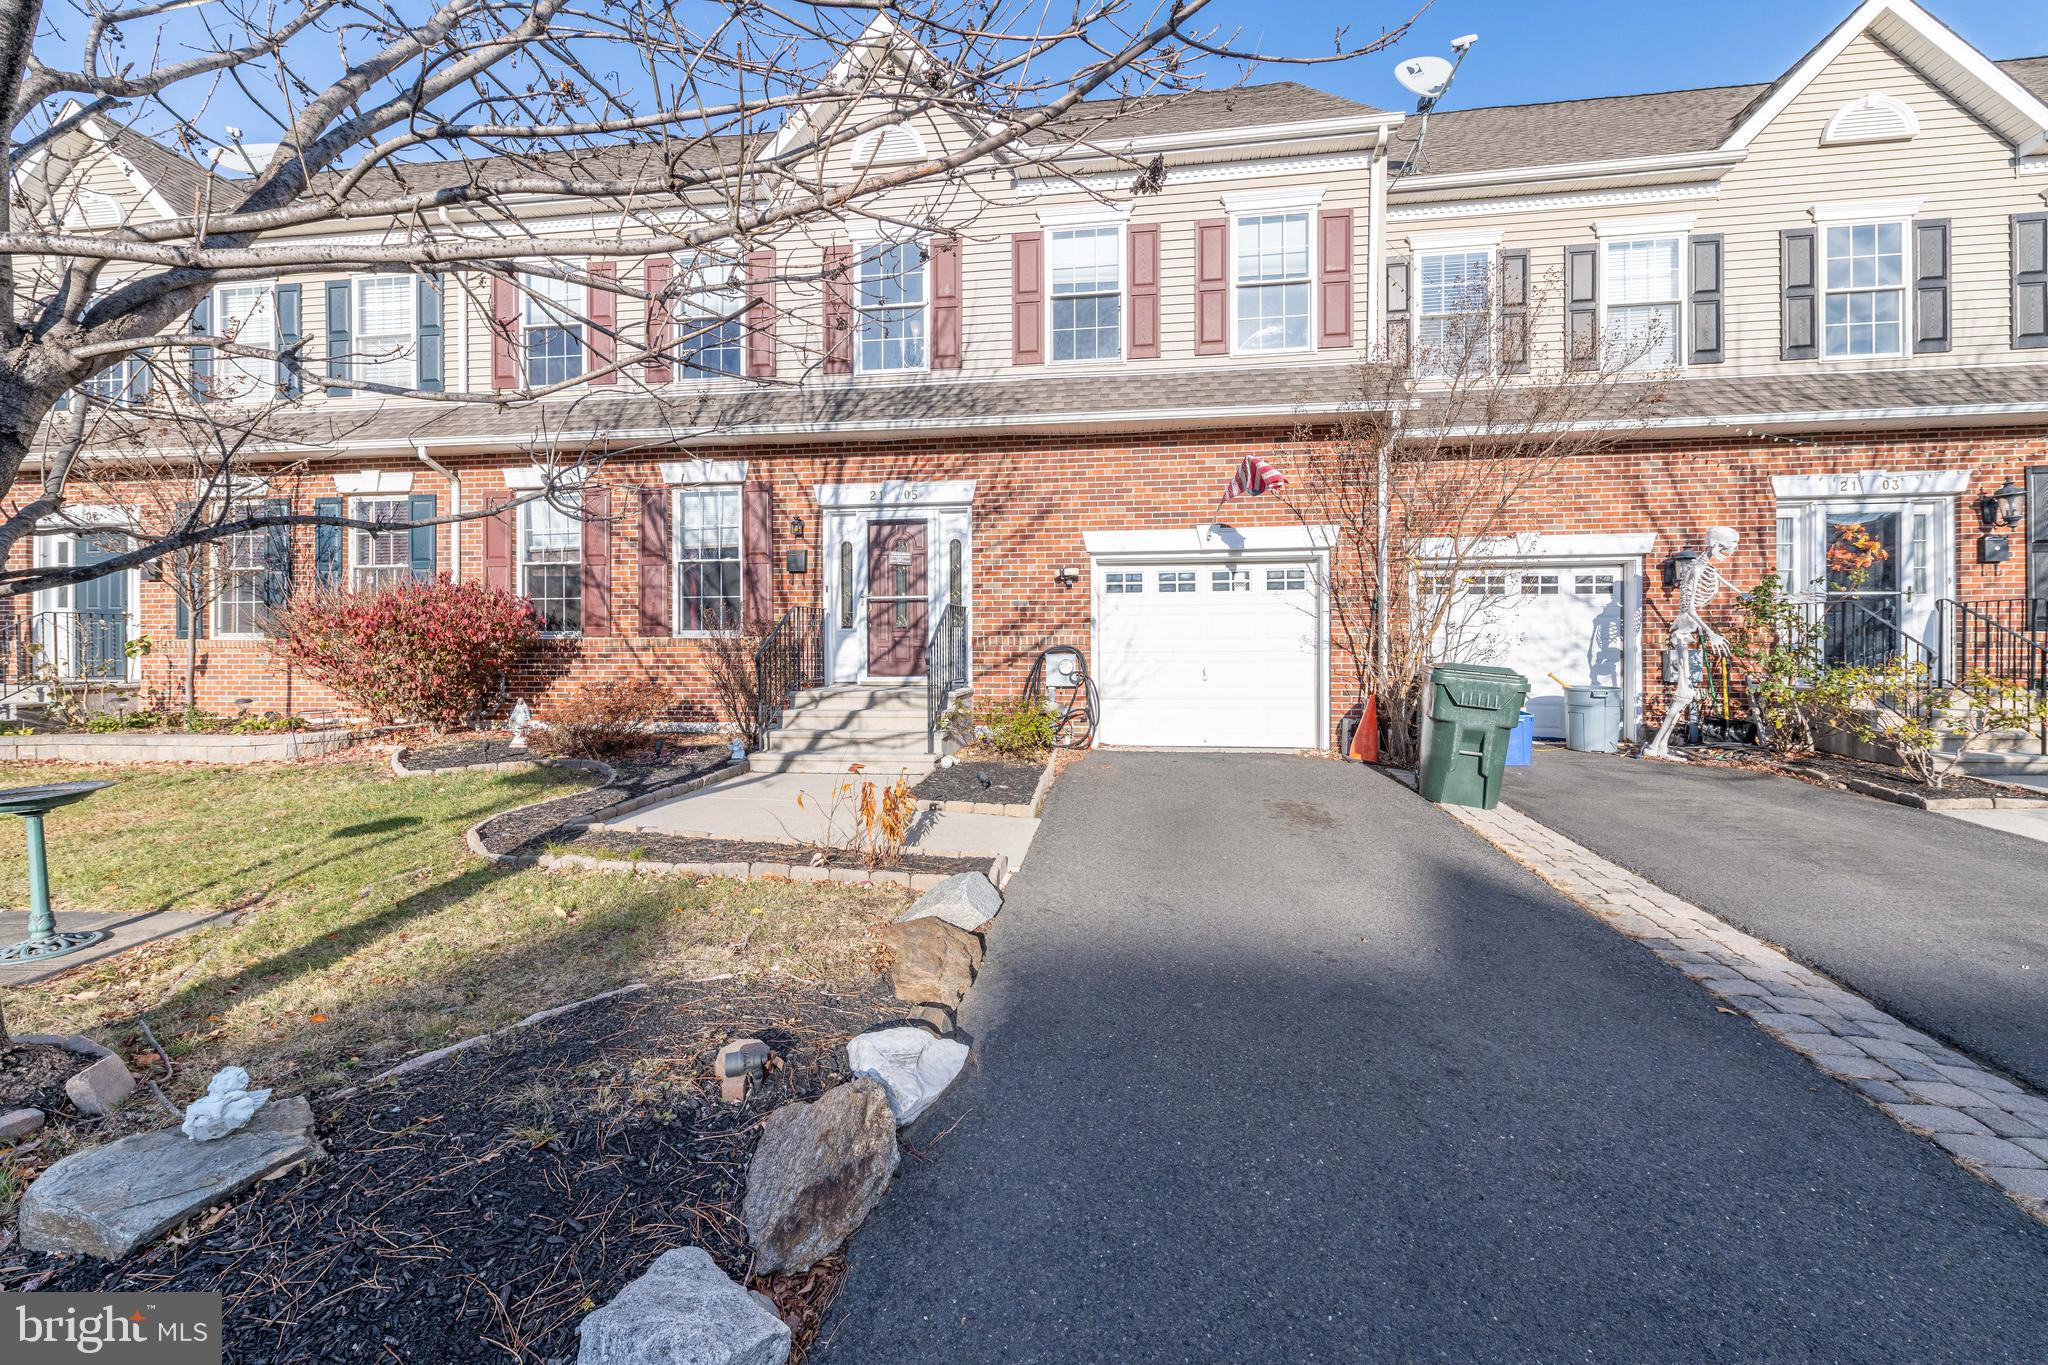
top-left (1507, 749), bottom-right (2048, 1089)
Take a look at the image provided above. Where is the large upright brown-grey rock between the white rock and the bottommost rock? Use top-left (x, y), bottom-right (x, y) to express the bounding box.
top-left (741, 1078), bottom-right (901, 1275)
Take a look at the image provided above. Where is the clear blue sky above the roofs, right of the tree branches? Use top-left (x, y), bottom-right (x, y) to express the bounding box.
top-left (1245, 0), bottom-right (2048, 108)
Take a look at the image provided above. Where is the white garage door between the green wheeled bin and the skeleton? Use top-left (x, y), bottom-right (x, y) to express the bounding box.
top-left (1446, 565), bottom-right (1626, 739)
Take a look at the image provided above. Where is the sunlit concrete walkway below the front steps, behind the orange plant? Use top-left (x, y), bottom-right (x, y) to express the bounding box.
top-left (610, 774), bottom-right (1038, 868)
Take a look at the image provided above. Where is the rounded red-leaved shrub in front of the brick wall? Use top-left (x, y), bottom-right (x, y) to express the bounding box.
top-left (274, 579), bottom-right (541, 731)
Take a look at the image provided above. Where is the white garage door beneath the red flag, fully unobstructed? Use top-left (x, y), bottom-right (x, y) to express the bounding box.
top-left (1094, 561), bottom-right (1323, 749)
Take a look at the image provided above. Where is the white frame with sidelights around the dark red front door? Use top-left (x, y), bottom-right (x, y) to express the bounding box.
top-left (817, 479), bottom-right (975, 684)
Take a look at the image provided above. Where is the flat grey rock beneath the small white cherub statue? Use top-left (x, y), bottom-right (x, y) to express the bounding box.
top-left (20, 1095), bottom-right (322, 1261)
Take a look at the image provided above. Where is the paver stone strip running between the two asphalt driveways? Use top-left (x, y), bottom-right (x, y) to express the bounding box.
top-left (1386, 774), bottom-right (2048, 1224)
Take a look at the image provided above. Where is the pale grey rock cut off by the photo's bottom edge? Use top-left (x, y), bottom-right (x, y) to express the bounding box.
top-left (575, 1246), bottom-right (791, 1365)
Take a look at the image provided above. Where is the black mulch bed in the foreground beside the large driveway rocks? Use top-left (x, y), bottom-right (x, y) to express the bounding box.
top-left (0, 978), bottom-right (899, 1365)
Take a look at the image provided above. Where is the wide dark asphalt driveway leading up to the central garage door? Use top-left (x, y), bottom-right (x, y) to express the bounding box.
top-left (813, 753), bottom-right (2048, 1365)
